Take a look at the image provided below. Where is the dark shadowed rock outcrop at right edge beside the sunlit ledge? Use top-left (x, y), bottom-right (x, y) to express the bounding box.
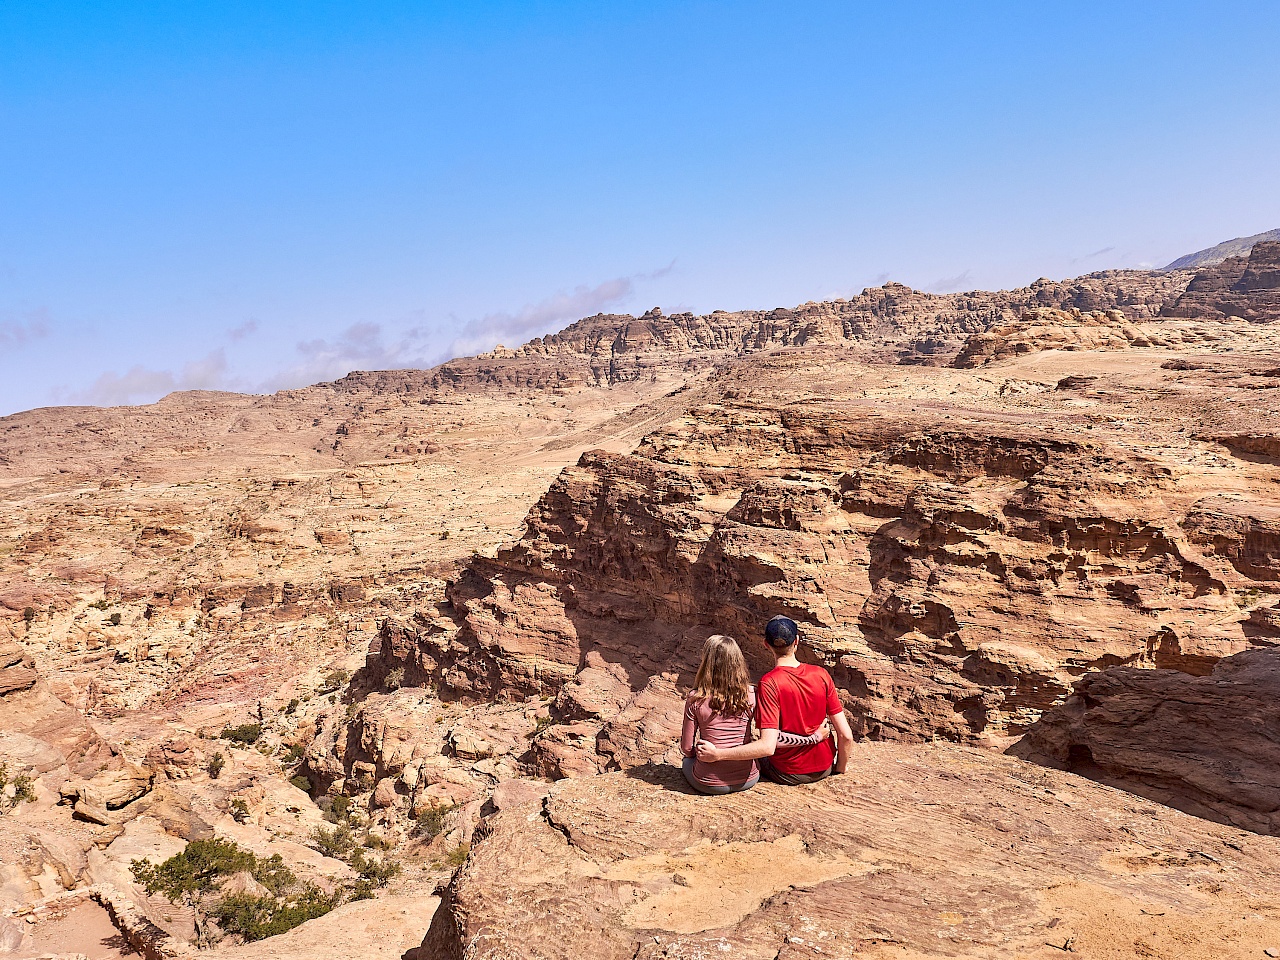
top-left (1015, 649), bottom-right (1280, 836)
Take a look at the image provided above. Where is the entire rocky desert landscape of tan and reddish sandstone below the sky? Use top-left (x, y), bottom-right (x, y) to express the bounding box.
top-left (0, 236), bottom-right (1280, 960)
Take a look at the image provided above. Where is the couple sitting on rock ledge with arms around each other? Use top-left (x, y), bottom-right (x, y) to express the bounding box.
top-left (680, 617), bottom-right (854, 794)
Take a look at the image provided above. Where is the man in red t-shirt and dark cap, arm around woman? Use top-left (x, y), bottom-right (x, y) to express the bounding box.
top-left (698, 617), bottom-right (854, 785)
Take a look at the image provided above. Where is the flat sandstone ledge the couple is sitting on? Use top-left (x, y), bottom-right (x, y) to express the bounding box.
top-left (406, 744), bottom-right (1280, 960)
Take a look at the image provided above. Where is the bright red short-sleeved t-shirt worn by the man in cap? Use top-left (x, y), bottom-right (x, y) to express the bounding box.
top-left (755, 663), bottom-right (845, 773)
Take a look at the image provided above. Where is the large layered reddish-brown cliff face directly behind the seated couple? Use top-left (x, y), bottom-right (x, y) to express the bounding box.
top-left (371, 324), bottom-right (1280, 776)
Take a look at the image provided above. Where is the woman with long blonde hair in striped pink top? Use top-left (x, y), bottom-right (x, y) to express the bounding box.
top-left (680, 634), bottom-right (829, 795)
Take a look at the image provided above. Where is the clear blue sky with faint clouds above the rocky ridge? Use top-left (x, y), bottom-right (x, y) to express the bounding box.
top-left (0, 0), bottom-right (1280, 413)
